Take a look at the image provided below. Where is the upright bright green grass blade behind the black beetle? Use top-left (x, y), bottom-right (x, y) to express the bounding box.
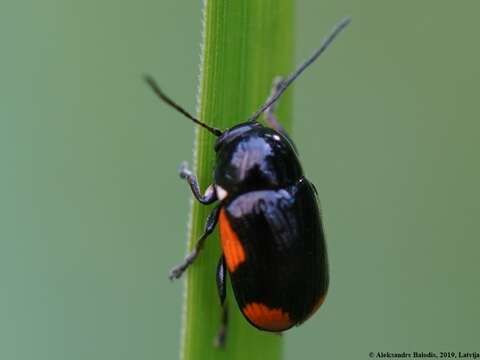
top-left (181, 0), bottom-right (294, 360)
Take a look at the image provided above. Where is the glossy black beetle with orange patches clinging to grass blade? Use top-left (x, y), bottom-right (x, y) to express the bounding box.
top-left (145, 18), bottom-right (350, 345)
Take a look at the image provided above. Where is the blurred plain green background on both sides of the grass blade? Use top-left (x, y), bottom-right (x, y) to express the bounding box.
top-left (0, 0), bottom-right (480, 360)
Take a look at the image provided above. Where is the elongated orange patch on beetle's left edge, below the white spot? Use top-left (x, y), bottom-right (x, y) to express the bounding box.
top-left (219, 209), bottom-right (246, 272)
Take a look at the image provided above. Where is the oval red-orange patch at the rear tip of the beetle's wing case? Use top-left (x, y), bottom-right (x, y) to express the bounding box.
top-left (242, 303), bottom-right (293, 331)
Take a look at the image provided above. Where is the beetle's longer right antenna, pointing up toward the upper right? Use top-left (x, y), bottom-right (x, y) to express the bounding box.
top-left (247, 17), bottom-right (351, 122)
